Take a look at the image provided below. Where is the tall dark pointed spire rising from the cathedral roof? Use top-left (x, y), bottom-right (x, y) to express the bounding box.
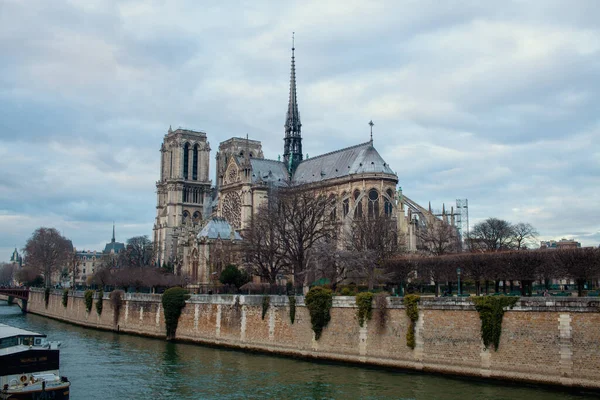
top-left (283, 35), bottom-right (302, 174)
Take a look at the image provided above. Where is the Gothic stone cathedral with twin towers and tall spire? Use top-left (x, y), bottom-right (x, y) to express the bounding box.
top-left (154, 47), bottom-right (454, 286)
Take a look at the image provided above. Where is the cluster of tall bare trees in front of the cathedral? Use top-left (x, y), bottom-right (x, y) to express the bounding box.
top-left (243, 189), bottom-right (399, 288)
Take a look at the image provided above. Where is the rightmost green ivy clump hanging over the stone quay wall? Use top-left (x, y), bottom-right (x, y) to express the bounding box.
top-left (471, 296), bottom-right (519, 351)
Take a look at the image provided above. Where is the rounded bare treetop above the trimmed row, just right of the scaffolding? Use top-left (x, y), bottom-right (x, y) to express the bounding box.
top-left (468, 218), bottom-right (514, 251)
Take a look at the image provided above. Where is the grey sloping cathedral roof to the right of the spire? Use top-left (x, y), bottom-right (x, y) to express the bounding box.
top-left (293, 142), bottom-right (396, 184)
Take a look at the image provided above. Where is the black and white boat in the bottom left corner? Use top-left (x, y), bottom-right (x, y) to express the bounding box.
top-left (0, 324), bottom-right (71, 400)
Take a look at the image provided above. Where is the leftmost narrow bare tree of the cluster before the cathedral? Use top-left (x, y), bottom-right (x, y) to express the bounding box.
top-left (243, 204), bottom-right (288, 284)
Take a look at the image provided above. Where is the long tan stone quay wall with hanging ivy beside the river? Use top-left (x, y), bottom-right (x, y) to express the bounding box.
top-left (28, 289), bottom-right (600, 389)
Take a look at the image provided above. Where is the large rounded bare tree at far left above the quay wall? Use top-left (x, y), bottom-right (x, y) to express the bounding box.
top-left (23, 228), bottom-right (73, 287)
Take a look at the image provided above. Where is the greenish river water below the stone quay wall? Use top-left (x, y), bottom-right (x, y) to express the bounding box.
top-left (0, 301), bottom-right (591, 400)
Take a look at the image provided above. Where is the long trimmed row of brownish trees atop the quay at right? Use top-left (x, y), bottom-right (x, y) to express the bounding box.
top-left (385, 248), bottom-right (600, 295)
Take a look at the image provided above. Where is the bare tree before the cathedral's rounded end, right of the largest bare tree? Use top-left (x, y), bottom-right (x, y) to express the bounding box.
top-left (346, 214), bottom-right (399, 289)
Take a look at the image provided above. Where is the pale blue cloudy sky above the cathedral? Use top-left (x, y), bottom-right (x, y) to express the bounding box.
top-left (0, 0), bottom-right (600, 261)
